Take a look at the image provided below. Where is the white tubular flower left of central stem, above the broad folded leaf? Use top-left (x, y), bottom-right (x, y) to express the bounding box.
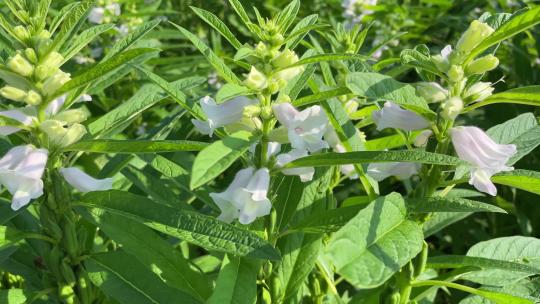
top-left (191, 96), bottom-right (257, 136)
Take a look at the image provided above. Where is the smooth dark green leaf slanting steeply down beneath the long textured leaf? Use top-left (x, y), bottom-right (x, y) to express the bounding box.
top-left (81, 209), bottom-right (210, 302)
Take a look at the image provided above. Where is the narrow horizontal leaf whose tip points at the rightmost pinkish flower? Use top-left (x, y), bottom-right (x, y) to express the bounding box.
top-left (284, 150), bottom-right (465, 168)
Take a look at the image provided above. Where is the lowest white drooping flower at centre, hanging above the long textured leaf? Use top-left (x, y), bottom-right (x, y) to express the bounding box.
top-left (210, 167), bottom-right (272, 225)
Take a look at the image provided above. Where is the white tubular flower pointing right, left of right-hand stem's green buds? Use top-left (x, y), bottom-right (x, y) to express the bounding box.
top-left (371, 101), bottom-right (429, 131)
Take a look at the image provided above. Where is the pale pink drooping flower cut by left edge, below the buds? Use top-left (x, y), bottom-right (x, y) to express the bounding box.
top-left (0, 145), bottom-right (48, 210)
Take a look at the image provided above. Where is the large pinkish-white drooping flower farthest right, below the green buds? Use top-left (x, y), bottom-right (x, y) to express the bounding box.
top-left (450, 127), bottom-right (517, 196)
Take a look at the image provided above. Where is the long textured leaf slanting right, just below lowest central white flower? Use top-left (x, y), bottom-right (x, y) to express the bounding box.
top-left (79, 191), bottom-right (279, 260)
